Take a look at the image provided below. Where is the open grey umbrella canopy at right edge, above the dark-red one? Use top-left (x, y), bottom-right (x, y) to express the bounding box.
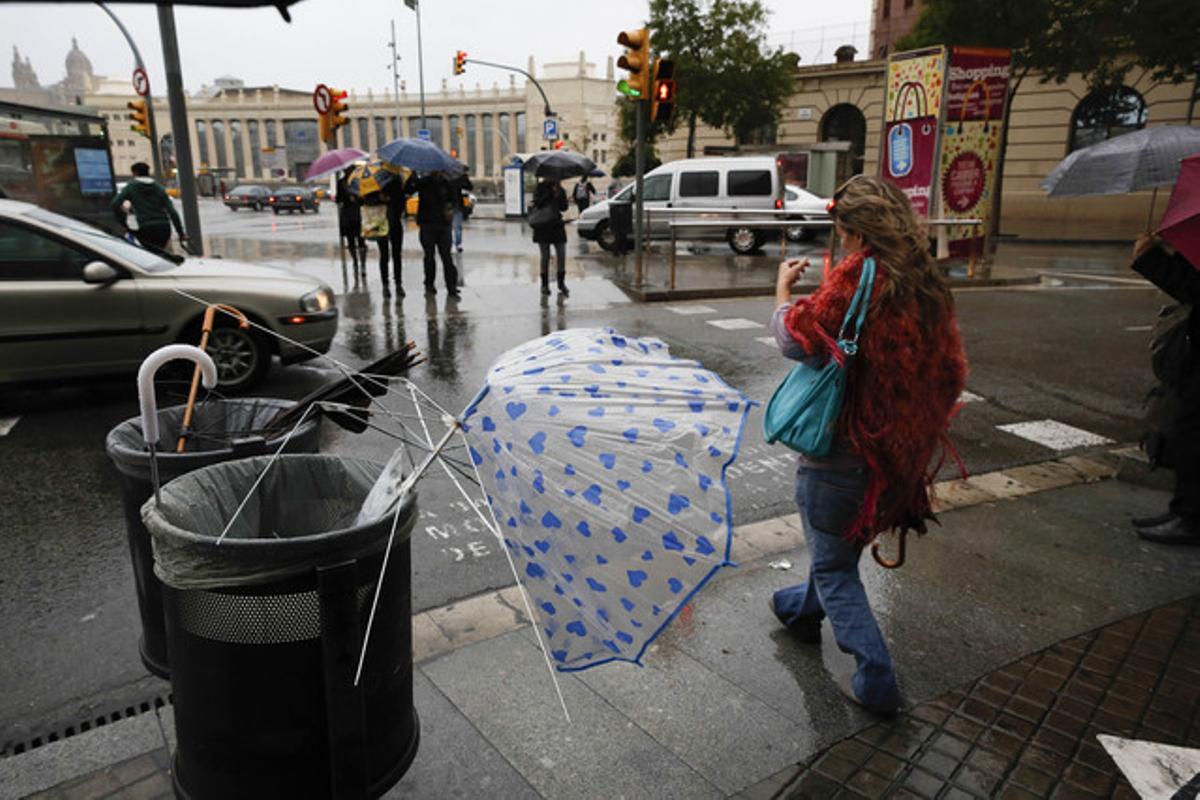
top-left (1042, 125), bottom-right (1200, 197)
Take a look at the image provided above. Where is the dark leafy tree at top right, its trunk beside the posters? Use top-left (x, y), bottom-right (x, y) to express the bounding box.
top-left (896, 0), bottom-right (1200, 244)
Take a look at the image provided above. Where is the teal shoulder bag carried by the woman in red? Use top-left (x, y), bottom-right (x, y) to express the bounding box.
top-left (762, 257), bottom-right (875, 458)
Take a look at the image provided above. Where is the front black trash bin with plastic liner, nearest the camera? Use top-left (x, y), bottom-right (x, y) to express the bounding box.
top-left (142, 455), bottom-right (419, 799)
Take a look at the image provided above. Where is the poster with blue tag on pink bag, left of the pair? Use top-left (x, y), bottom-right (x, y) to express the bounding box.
top-left (880, 47), bottom-right (946, 218)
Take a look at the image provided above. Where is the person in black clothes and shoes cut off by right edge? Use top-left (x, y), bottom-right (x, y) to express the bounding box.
top-left (1133, 234), bottom-right (1200, 545)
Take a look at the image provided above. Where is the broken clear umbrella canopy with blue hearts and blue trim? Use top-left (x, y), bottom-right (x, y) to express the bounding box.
top-left (462, 329), bottom-right (752, 672)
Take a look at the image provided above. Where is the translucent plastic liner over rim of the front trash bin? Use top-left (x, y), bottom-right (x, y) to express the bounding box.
top-left (142, 455), bottom-right (415, 589)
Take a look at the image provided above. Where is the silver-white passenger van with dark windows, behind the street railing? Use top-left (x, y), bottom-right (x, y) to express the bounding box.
top-left (575, 156), bottom-right (806, 254)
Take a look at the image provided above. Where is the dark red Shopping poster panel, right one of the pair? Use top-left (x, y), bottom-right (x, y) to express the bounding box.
top-left (937, 47), bottom-right (1012, 257)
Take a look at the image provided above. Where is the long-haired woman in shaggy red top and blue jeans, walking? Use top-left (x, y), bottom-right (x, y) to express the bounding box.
top-left (770, 175), bottom-right (966, 714)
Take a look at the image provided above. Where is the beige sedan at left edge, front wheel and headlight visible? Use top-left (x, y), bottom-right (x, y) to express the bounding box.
top-left (0, 200), bottom-right (337, 392)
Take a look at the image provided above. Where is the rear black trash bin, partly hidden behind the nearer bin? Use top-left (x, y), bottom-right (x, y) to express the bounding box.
top-left (104, 397), bottom-right (320, 678)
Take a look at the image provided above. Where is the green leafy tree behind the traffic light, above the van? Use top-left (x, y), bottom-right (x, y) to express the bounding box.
top-left (649, 0), bottom-right (798, 158)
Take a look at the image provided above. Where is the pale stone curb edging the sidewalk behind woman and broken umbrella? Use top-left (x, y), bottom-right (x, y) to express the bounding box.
top-left (413, 445), bottom-right (1136, 664)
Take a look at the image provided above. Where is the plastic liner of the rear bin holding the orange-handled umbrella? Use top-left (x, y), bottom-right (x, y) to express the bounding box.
top-left (104, 397), bottom-right (320, 482)
